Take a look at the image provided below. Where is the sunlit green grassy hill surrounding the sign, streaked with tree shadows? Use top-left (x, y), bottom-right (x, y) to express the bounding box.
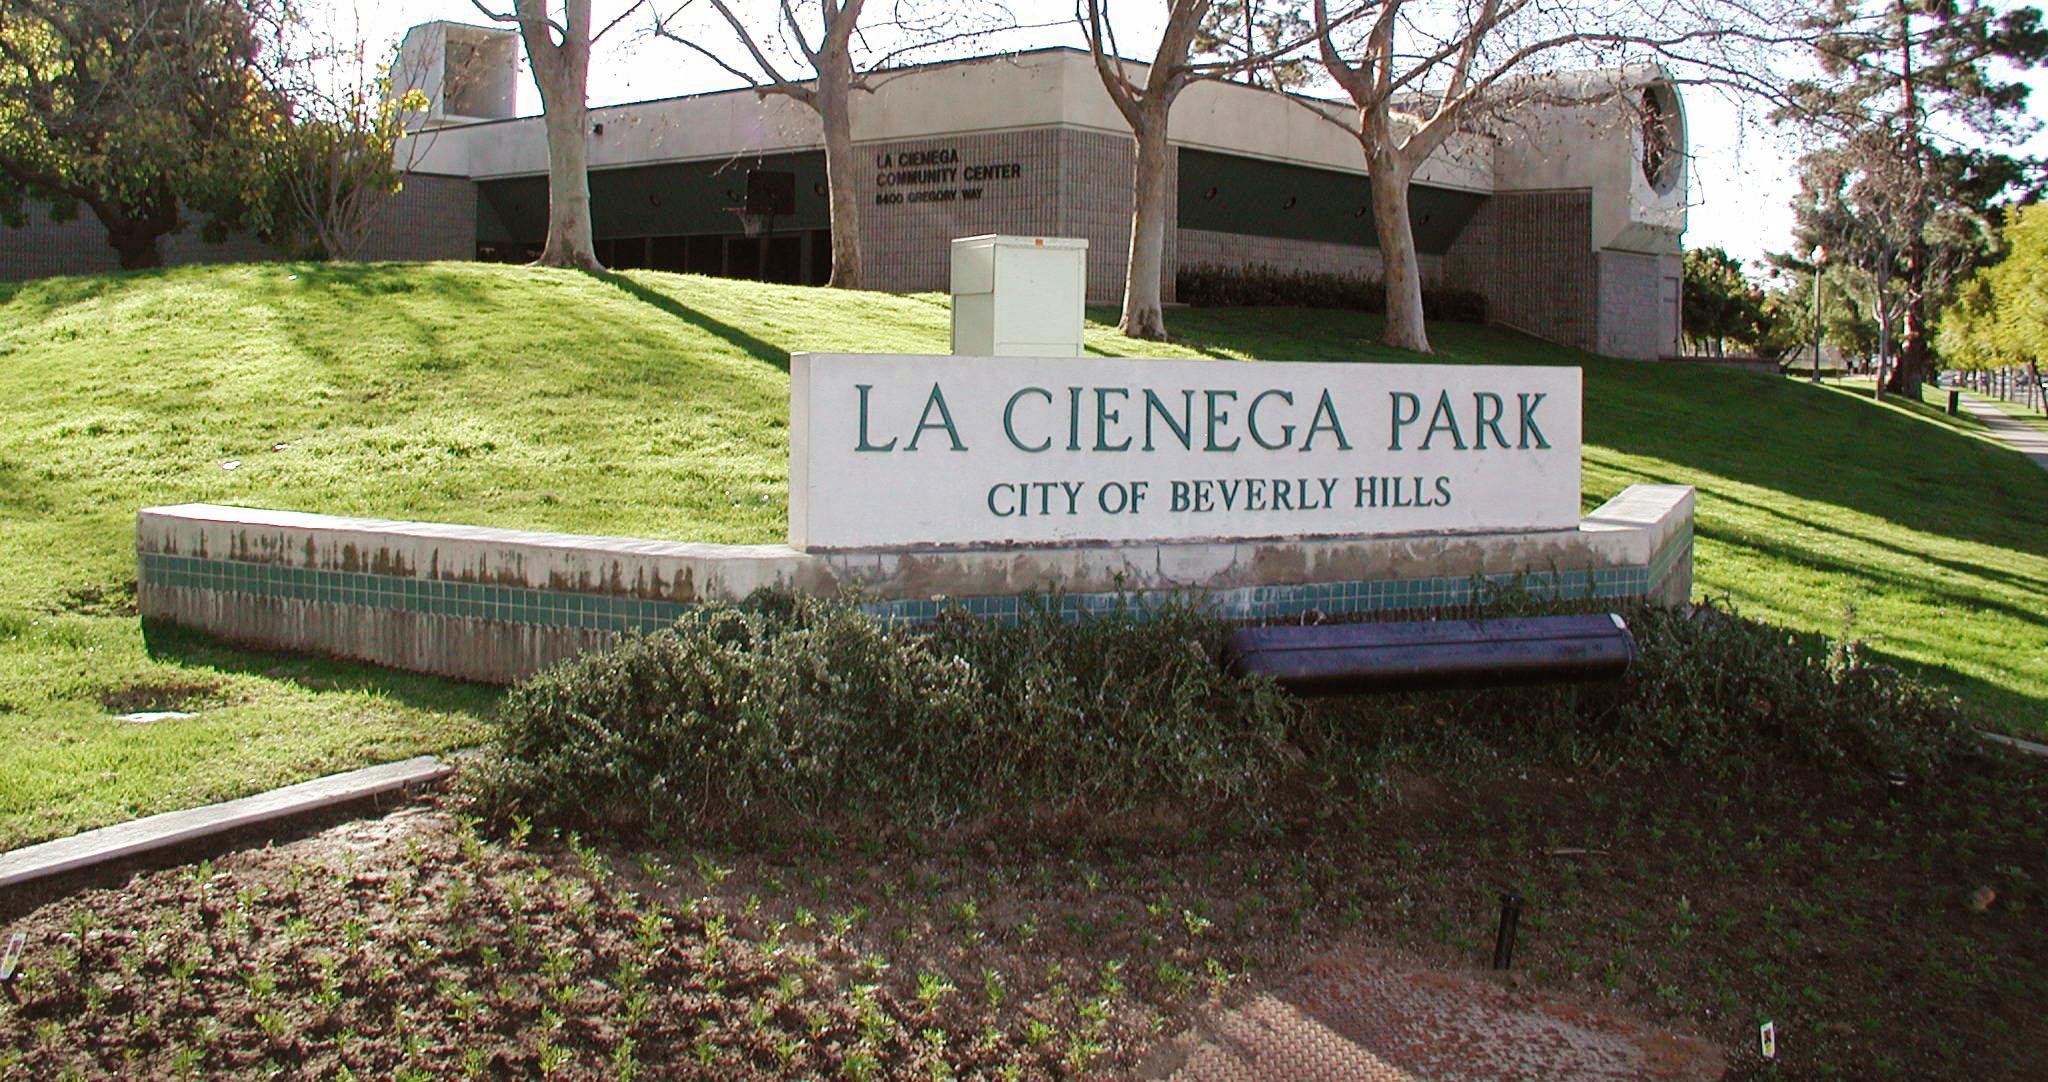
top-left (0, 264), bottom-right (2048, 848)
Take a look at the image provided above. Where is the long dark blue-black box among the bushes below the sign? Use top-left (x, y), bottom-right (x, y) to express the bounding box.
top-left (1223, 613), bottom-right (1636, 695)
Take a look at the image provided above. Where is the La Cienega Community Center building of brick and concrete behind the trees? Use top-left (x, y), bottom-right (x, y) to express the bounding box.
top-left (0, 23), bottom-right (1686, 359)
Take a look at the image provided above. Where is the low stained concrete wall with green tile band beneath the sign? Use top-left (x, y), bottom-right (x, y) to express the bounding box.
top-left (135, 486), bottom-right (1694, 682)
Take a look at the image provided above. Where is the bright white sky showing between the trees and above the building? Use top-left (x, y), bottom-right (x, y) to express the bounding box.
top-left (327, 0), bottom-right (2048, 260)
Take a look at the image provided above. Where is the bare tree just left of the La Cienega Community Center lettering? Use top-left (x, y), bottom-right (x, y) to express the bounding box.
top-left (653, 0), bottom-right (1016, 289)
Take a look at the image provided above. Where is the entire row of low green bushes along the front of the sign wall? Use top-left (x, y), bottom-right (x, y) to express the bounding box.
top-left (487, 598), bottom-right (1960, 830)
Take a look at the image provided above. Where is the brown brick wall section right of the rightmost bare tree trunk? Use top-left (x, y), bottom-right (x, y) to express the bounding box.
top-left (1444, 191), bottom-right (1599, 350)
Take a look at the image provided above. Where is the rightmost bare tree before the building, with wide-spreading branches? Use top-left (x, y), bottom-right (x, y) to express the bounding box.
top-left (1313, 0), bottom-right (1796, 352)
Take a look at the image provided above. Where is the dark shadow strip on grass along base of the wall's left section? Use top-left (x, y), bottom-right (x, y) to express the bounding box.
top-left (141, 617), bottom-right (504, 719)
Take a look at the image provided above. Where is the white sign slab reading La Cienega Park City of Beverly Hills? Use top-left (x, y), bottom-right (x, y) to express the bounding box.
top-left (788, 352), bottom-right (1581, 549)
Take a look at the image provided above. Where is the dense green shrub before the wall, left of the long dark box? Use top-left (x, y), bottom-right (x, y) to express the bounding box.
top-left (492, 598), bottom-right (1288, 826)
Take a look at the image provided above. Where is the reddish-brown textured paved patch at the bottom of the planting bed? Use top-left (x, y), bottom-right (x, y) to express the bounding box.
top-left (1139, 949), bottom-right (1724, 1082)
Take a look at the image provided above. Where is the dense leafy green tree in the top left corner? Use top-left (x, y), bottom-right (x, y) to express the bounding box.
top-left (0, 0), bottom-right (287, 268)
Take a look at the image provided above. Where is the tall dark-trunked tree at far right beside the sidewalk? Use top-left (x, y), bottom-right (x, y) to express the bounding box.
top-left (1784, 0), bottom-right (2048, 391)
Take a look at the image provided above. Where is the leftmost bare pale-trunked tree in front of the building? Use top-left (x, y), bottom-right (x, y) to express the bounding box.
top-left (471, 0), bottom-right (645, 271)
